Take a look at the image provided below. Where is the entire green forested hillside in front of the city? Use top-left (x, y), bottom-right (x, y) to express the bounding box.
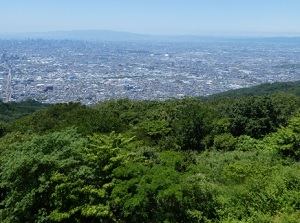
top-left (0, 83), bottom-right (300, 223)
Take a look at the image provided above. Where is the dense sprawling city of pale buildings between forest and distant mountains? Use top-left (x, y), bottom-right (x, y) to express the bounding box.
top-left (0, 38), bottom-right (300, 104)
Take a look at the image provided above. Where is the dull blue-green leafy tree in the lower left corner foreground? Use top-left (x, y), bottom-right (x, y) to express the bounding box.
top-left (0, 129), bottom-right (86, 223)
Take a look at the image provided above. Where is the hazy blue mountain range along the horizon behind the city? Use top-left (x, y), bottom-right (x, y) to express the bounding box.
top-left (0, 30), bottom-right (300, 42)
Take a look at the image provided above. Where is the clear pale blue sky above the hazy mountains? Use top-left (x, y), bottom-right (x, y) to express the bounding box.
top-left (0, 0), bottom-right (300, 36)
